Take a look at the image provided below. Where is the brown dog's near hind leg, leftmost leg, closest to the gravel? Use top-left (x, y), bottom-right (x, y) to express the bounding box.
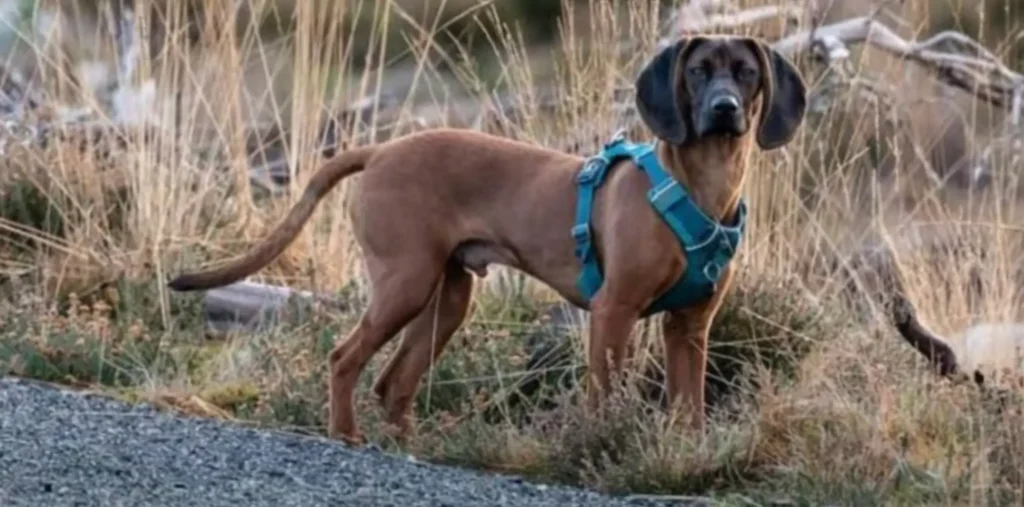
top-left (328, 254), bottom-right (443, 443)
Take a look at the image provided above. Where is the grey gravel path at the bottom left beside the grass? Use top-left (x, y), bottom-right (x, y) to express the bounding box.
top-left (0, 378), bottom-right (678, 507)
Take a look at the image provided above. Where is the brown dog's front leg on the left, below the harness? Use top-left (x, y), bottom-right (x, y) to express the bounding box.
top-left (587, 295), bottom-right (640, 411)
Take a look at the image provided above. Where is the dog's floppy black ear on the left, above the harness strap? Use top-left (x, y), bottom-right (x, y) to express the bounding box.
top-left (636, 37), bottom-right (699, 144)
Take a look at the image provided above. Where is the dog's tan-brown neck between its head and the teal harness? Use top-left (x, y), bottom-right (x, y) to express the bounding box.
top-left (657, 134), bottom-right (752, 223)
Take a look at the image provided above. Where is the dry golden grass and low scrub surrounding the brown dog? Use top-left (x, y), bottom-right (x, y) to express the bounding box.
top-left (0, 2), bottom-right (1024, 505)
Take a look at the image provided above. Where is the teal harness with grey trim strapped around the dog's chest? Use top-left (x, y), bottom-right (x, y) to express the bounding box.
top-left (572, 135), bottom-right (746, 316)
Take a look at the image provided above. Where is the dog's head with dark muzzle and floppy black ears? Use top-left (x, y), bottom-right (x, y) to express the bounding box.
top-left (636, 36), bottom-right (807, 151)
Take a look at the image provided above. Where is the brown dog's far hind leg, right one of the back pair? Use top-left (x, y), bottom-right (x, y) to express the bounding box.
top-left (374, 260), bottom-right (473, 436)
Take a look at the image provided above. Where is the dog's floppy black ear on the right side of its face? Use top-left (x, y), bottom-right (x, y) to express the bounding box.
top-left (750, 39), bottom-right (807, 151)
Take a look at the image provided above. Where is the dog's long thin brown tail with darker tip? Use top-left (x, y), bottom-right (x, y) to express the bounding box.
top-left (167, 146), bottom-right (376, 291)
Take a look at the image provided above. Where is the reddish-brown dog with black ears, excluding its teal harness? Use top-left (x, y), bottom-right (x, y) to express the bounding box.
top-left (170, 36), bottom-right (806, 442)
